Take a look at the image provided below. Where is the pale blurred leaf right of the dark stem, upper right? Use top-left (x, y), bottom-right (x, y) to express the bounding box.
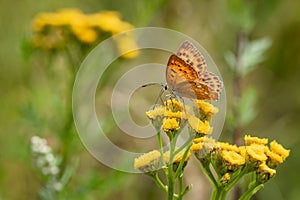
top-left (240, 38), bottom-right (272, 76)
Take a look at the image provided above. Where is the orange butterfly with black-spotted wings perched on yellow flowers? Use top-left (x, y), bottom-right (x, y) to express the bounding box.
top-left (166, 41), bottom-right (223, 100)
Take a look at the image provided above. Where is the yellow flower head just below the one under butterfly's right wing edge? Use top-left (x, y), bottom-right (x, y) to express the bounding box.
top-left (188, 115), bottom-right (212, 136)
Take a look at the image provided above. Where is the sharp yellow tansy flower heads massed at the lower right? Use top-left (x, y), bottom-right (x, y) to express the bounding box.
top-left (191, 135), bottom-right (290, 186)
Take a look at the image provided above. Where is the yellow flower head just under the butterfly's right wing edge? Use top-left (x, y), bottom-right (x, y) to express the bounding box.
top-left (194, 100), bottom-right (219, 121)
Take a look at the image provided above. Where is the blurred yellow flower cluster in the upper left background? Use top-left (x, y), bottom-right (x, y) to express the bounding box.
top-left (32, 8), bottom-right (138, 58)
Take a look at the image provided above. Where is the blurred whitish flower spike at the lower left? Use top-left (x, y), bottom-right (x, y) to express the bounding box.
top-left (31, 136), bottom-right (62, 191)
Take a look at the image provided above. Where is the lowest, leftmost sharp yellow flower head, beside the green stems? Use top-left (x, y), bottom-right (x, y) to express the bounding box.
top-left (134, 150), bottom-right (160, 172)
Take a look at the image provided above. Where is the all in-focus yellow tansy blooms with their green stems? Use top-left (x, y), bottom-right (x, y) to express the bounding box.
top-left (134, 99), bottom-right (290, 199)
